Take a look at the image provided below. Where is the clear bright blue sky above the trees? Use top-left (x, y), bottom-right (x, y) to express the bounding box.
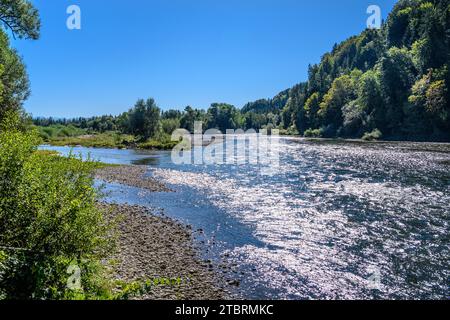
top-left (11, 0), bottom-right (396, 117)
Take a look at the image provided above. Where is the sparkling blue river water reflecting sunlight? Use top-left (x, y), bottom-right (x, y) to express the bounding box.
top-left (40, 138), bottom-right (450, 299)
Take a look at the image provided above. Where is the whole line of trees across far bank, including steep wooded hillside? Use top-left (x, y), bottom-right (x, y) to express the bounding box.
top-left (35, 0), bottom-right (450, 141)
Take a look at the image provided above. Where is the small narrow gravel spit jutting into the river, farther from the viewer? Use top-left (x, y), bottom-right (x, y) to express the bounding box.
top-left (95, 165), bottom-right (171, 192)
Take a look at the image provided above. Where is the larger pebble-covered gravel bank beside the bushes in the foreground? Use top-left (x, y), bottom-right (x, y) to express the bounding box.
top-left (99, 204), bottom-right (227, 300)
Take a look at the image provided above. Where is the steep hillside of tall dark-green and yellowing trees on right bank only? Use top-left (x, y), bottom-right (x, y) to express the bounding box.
top-left (268, 0), bottom-right (450, 141)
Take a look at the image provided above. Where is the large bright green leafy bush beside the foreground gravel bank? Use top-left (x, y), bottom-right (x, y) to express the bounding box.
top-left (0, 115), bottom-right (118, 299)
